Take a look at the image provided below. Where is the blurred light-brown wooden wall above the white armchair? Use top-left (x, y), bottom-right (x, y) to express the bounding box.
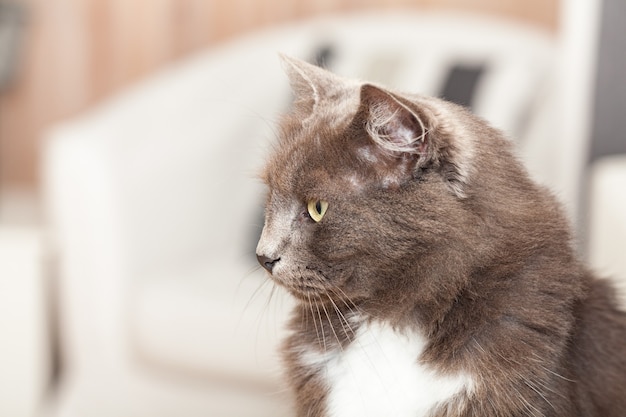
top-left (0, 0), bottom-right (558, 187)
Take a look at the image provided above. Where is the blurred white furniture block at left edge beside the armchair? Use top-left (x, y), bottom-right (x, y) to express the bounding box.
top-left (0, 224), bottom-right (49, 417)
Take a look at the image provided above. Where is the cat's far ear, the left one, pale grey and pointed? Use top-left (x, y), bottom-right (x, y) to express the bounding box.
top-left (280, 54), bottom-right (356, 121)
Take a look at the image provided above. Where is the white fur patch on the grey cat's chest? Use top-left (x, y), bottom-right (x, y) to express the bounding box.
top-left (303, 322), bottom-right (472, 417)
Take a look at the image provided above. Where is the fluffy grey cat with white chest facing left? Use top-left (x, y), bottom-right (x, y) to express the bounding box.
top-left (257, 56), bottom-right (626, 417)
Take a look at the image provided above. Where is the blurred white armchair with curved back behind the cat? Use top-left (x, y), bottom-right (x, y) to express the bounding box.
top-left (42, 13), bottom-right (616, 417)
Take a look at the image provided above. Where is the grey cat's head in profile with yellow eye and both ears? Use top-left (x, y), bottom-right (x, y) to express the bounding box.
top-left (257, 57), bottom-right (512, 308)
